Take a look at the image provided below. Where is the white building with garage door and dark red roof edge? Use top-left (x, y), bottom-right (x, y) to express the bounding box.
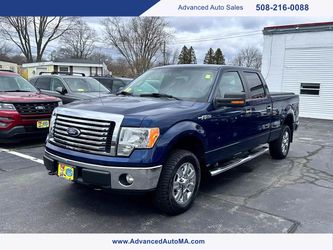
top-left (262, 22), bottom-right (333, 119)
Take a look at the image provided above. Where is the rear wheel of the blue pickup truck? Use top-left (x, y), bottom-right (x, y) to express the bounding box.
top-left (269, 125), bottom-right (291, 159)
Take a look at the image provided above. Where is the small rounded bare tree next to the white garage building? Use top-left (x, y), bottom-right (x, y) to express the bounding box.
top-left (233, 47), bottom-right (262, 69)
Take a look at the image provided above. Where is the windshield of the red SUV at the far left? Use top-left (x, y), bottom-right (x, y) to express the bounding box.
top-left (0, 75), bottom-right (37, 92)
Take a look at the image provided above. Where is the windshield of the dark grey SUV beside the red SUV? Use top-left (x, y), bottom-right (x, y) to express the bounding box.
top-left (65, 77), bottom-right (110, 92)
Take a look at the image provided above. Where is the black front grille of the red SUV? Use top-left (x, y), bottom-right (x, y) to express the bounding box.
top-left (14, 102), bottom-right (58, 115)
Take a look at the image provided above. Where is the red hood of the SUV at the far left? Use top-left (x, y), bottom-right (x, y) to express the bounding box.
top-left (0, 92), bottom-right (60, 102)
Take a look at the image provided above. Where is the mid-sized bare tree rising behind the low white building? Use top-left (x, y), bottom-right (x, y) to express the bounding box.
top-left (58, 19), bottom-right (96, 59)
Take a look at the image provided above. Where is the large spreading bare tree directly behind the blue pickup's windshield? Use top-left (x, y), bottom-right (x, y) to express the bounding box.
top-left (102, 17), bottom-right (170, 75)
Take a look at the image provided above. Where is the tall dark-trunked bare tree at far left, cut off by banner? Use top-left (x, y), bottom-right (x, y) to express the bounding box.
top-left (0, 16), bottom-right (75, 62)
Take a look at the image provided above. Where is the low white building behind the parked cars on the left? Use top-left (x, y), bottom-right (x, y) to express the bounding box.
top-left (22, 59), bottom-right (109, 79)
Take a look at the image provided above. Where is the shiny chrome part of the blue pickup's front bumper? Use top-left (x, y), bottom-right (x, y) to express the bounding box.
top-left (44, 150), bottom-right (162, 191)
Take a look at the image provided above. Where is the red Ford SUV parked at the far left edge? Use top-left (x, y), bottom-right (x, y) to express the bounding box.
top-left (0, 70), bottom-right (62, 143)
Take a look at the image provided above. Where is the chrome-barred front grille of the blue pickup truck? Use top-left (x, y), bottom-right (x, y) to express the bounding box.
top-left (53, 114), bottom-right (115, 154)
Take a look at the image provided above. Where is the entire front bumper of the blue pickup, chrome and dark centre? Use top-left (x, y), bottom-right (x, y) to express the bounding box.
top-left (44, 151), bottom-right (162, 191)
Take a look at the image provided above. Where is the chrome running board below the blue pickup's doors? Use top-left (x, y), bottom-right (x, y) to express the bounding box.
top-left (209, 147), bottom-right (269, 176)
